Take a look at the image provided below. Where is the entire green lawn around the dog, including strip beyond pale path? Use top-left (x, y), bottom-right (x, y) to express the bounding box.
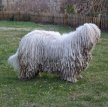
top-left (0, 21), bottom-right (108, 107)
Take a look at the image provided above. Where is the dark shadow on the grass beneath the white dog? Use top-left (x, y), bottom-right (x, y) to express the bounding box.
top-left (1, 73), bottom-right (88, 87)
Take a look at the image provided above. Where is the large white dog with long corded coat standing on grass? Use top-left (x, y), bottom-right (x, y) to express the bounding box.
top-left (8, 23), bottom-right (101, 83)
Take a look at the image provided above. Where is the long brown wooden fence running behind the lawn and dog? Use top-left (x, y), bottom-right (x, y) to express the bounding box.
top-left (0, 11), bottom-right (108, 32)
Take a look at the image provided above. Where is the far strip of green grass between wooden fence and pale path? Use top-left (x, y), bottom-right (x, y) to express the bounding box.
top-left (0, 21), bottom-right (72, 33)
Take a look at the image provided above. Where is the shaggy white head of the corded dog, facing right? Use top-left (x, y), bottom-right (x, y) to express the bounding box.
top-left (76, 23), bottom-right (101, 51)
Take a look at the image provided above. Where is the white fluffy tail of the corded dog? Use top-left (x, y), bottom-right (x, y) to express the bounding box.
top-left (8, 52), bottom-right (19, 70)
